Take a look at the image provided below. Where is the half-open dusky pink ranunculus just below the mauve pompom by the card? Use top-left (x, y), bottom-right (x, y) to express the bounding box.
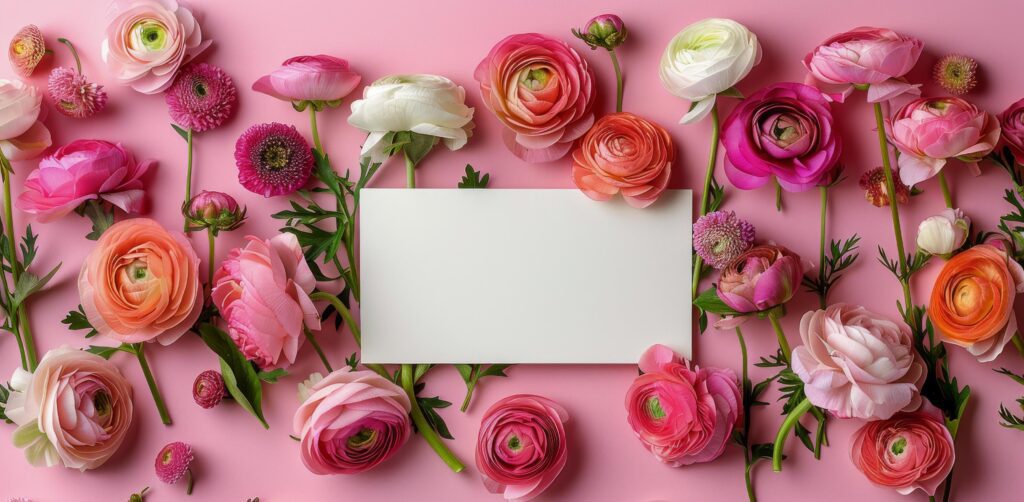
top-left (718, 245), bottom-right (804, 313)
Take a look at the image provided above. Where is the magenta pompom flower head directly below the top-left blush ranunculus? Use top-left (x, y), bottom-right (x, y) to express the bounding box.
top-left (166, 62), bottom-right (239, 132)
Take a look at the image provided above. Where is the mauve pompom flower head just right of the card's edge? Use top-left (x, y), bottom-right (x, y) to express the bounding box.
top-left (693, 211), bottom-right (755, 270)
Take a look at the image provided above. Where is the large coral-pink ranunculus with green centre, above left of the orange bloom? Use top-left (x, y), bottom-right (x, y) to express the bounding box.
top-left (473, 33), bottom-right (597, 162)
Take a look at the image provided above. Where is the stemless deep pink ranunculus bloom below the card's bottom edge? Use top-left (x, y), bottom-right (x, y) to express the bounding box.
top-left (476, 394), bottom-right (569, 502)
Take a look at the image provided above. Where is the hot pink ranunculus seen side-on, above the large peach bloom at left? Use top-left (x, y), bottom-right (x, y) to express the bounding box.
top-left (15, 139), bottom-right (156, 221)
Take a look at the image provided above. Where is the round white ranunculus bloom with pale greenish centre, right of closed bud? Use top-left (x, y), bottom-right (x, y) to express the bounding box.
top-left (660, 18), bottom-right (761, 123)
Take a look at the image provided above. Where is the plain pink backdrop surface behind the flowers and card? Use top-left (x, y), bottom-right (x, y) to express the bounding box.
top-left (0, 0), bottom-right (1024, 502)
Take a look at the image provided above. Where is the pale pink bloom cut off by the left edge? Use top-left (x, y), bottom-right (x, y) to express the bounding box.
top-left (0, 79), bottom-right (51, 161)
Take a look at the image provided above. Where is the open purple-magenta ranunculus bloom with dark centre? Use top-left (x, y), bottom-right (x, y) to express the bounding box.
top-left (722, 82), bottom-right (842, 192)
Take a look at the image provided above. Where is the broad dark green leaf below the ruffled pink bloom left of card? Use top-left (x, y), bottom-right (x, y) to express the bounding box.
top-left (199, 324), bottom-right (270, 428)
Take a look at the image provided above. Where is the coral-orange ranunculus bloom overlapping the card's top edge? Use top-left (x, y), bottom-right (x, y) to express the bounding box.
top-left (572, 112), bottom-right (676, 208)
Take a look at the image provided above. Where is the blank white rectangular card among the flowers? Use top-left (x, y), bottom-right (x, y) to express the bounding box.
top-left (359, 189), bottom-right (692, 364)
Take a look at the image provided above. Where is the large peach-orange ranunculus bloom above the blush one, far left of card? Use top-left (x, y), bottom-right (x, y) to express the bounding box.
top-left (78, 218), bottom-right (203, 345)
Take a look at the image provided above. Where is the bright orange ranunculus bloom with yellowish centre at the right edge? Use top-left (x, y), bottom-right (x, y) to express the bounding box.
top-left (928, 244), bottom-right (1024, 363)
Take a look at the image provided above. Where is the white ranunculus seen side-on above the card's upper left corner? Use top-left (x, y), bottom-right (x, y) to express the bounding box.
top-left (348, 75), bottom-right (473, 162)
